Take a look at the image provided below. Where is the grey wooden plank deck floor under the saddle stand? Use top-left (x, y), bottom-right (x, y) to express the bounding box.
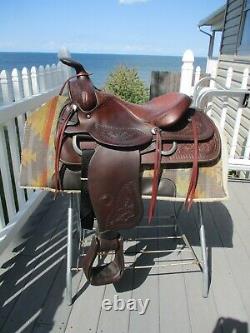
top-left (0, 183), bottom-right (250, 333)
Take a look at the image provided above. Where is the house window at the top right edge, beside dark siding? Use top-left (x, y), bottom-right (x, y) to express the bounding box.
top-left (239, 0), bottom-right (250, 55)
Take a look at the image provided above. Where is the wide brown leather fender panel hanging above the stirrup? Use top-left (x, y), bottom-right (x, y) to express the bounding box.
top-left (88, 146), bottom-right (143, 231)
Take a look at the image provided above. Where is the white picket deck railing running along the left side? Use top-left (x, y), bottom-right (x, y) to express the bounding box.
top-left (0, 57), bottom-right (69, 252)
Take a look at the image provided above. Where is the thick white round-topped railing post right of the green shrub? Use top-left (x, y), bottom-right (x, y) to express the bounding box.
top-left (180, 50), bottom-right (194, 95)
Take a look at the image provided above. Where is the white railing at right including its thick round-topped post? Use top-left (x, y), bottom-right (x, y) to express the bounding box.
top-left (180, 50), bottom-right (250, 171)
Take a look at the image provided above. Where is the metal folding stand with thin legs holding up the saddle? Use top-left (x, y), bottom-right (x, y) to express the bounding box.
top-left (66, 193), bottom-right (209, 305)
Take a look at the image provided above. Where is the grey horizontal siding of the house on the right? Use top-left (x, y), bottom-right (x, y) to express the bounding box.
top-left (212, 0), bottom-right (250, 157)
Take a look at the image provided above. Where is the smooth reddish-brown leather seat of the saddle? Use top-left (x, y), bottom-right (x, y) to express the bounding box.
top-left (118, 92), bottom-right (192, 129)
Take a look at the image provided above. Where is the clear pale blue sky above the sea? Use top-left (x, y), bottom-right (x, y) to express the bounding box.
top-left (0, 0), bottom-right (225, 56)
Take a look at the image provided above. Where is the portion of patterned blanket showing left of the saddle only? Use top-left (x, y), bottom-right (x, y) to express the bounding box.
top-left (20, 96), bottom-right (67, 190)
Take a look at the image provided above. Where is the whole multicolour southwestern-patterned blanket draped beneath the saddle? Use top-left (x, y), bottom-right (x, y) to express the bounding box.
top-left (20, 96), bottom-right (228, 201)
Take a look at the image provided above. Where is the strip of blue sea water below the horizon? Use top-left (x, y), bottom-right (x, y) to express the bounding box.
top-left (0, 52), bottom-right (206, 88)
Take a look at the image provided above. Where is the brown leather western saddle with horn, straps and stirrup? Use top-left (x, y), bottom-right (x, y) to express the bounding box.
top-left (53, 58), bottom-right (221, 285)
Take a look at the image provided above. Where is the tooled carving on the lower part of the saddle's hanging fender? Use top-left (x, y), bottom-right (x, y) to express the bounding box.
top-left (101, 181), bottom-right (141, 230)
